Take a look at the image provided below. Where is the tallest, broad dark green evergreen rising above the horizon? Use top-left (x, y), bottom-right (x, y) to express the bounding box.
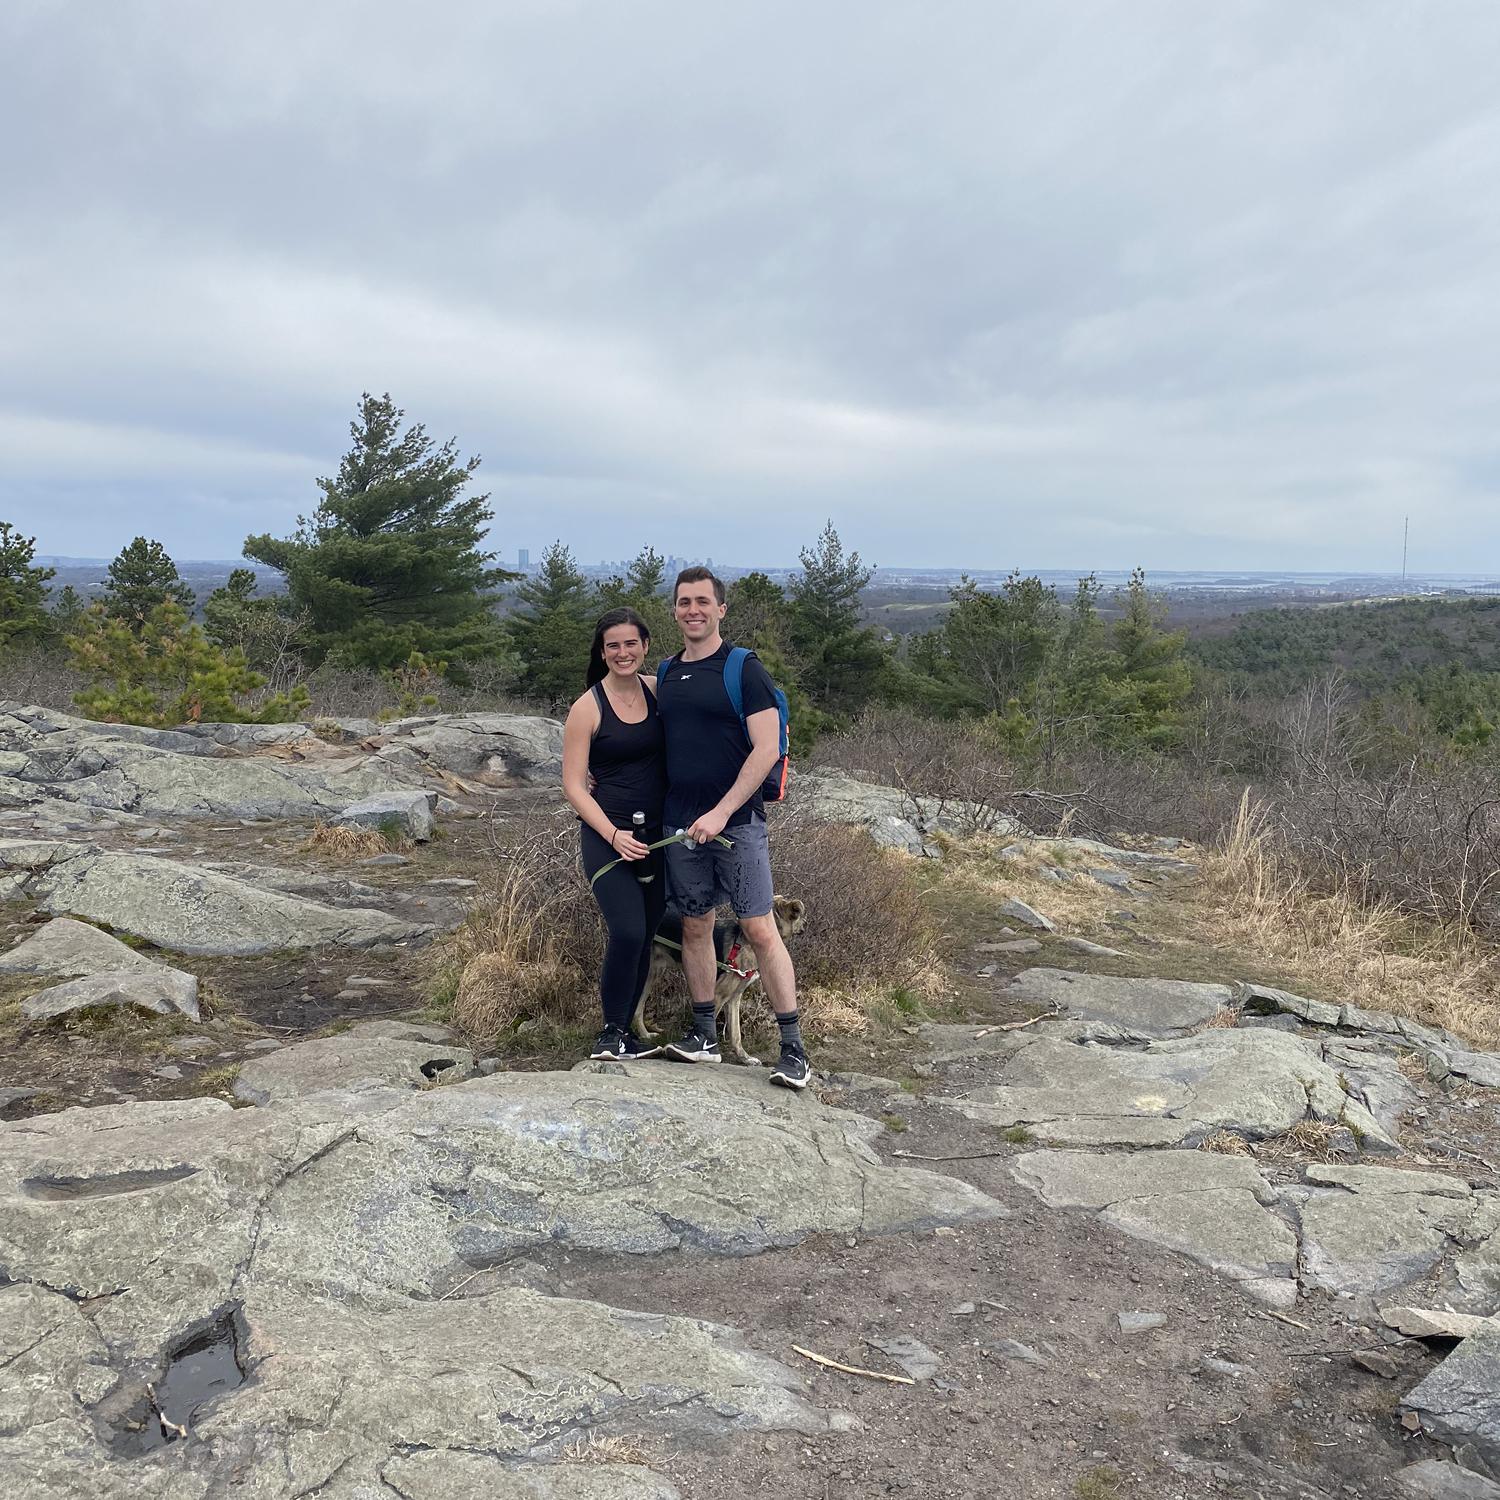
top-left (245, 392), bottom-right (515, 680)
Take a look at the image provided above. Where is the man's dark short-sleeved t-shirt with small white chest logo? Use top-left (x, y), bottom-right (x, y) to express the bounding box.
top-left (657, 642), bottom-right (776, 830)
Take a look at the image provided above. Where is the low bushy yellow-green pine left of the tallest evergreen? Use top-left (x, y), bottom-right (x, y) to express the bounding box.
top-left (68, 600), bottom-right (308, 728)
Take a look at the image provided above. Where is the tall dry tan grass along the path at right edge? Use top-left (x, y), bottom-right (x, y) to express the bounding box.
top-left (1190, 795), bottom-right (1500, 1047)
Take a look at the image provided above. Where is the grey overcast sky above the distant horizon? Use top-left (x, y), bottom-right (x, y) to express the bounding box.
top-left (0, 0), bottom-right (1500, 573)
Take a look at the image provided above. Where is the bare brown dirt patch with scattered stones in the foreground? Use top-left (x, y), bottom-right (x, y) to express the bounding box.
top-left (548, 1100), bottom-right (1439, 1500)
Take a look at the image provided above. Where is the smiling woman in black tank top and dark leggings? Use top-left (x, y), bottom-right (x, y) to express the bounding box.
top-left (563, 609), bottom-right (666, 1058)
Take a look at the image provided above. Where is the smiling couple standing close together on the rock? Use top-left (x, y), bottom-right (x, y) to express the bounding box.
top-left (563, 567), bottom-right (810, 1089)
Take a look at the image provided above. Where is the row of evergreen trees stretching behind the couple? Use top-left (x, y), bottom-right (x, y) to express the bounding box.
top-left (0, 393), bottom-right (1193, 753)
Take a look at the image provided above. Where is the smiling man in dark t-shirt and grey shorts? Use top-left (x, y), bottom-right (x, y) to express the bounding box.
top-left (657, 567), bottom-right (812, 1089)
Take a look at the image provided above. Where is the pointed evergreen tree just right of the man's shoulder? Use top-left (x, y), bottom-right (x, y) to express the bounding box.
top-left (788, 521), bottom-right (887, 714)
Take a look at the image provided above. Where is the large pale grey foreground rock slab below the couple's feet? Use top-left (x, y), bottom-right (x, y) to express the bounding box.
top-left (0, 1062), bottom-right (1002, 1500)
